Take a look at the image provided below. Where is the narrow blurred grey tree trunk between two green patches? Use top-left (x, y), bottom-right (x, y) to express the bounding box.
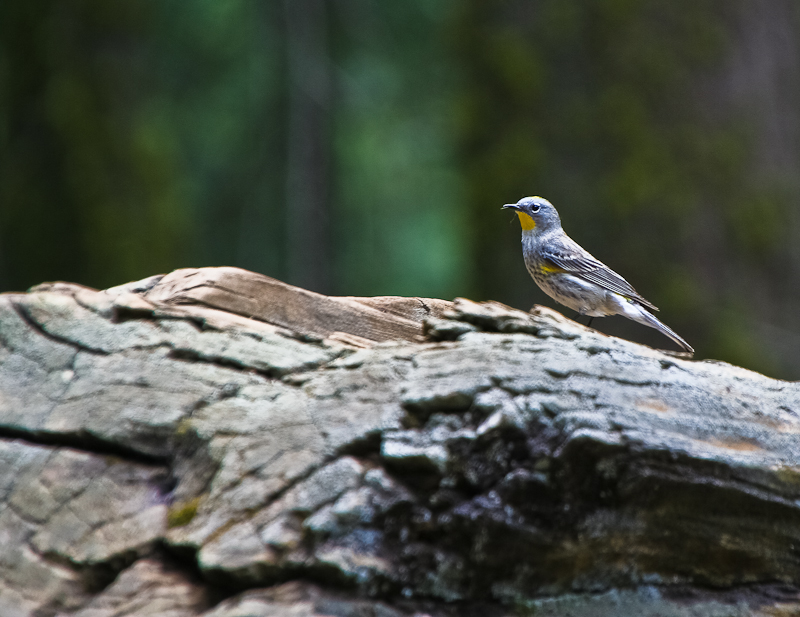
top-left (284, 0), bottom-right (332, 292)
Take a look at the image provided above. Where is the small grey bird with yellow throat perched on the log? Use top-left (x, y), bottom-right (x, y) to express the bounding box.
top-left (503, 197), bottom-right (694, 354)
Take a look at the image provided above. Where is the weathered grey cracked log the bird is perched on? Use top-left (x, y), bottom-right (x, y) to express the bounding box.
top-left (0, 268), bottom-right (800, 617)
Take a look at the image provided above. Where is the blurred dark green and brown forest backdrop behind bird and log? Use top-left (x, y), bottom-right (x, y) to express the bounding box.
top-left (0, 0), bottom-right (800, 379)
